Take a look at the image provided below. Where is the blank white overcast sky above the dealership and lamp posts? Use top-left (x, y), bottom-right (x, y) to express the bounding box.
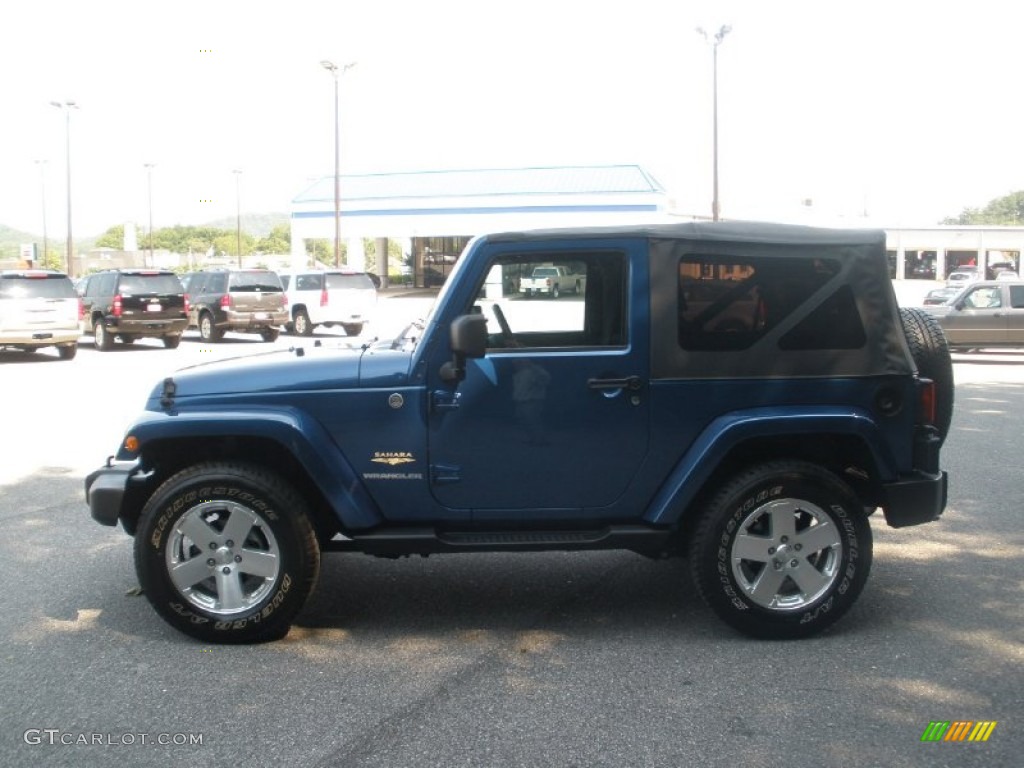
top-left (0, 0), bottom-right (1024, 239)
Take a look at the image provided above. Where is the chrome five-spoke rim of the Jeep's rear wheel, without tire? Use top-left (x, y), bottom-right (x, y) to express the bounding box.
top-left (729, 499), bottom-right (843, 611)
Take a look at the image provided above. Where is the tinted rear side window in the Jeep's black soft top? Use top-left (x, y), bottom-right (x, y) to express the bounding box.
top-left (678, 254), bottom-right (847, 351)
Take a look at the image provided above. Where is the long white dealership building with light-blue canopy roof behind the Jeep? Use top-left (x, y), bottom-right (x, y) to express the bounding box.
top-left (291, 165), bottom-right (1024, 286)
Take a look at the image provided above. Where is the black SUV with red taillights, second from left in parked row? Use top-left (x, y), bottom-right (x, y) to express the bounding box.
top-left (79, 269), bottom-right (188, 351)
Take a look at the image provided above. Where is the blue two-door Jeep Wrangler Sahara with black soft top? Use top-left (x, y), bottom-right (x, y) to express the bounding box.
top-left (86, 222), bottom-right (953, 642)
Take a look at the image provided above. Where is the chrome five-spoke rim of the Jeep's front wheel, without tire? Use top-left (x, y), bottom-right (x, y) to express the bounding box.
top-left (165, 501), bottom-right (281, 616)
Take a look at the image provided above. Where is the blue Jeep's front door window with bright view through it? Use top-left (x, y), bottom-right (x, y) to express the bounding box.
top-left (470, 251), bottom-right (628, 350)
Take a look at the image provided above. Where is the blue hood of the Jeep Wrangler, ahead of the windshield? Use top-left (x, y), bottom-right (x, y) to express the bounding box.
top-left (147, 346), bottom-right (410, 410)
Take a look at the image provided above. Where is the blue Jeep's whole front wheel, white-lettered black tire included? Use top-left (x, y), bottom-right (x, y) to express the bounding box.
top-left (135, 463), bottom-right (319, 643)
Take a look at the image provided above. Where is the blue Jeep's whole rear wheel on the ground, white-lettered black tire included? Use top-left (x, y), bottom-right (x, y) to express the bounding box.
top-left (689, 461), bottom-right (871, 640)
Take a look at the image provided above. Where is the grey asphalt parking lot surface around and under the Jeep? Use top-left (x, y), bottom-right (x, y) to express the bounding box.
top-left (0, 296), bottom-right (1024, 768)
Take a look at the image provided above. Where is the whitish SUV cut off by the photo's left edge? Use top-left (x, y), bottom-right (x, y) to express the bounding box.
top-left (0, 269), bottom-right (82, 360)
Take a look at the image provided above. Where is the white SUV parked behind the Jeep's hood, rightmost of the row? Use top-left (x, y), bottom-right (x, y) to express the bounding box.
top-left (280, 269), bottom-right (377, 336)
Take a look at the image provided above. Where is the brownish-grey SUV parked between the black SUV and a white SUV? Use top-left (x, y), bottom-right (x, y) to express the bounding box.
top-left (181, 269), bottom-right (288, 341)
